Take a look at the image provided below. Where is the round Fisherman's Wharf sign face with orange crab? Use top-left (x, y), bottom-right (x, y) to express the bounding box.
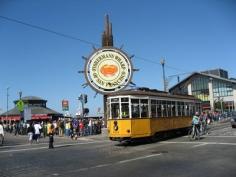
top-left (85, 47), bottom-right (133, 94)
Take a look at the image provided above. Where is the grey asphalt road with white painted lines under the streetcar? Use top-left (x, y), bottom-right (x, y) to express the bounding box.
top-left (0, 122), bottom-right (236, 177)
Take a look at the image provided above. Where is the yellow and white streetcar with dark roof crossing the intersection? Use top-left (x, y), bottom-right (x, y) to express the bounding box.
top-left (106, 88), bottom-right (201, 141)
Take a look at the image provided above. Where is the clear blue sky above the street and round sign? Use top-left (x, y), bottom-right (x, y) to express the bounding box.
top-left (0, 0), bottom-right (236, 115)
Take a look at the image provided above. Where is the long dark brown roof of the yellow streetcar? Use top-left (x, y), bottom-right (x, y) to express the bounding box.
top-left (107, 87), bottom-right (199, 100)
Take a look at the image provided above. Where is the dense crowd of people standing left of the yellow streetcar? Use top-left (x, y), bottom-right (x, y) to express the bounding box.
top-left (1, 118), bottom-right (102, 143)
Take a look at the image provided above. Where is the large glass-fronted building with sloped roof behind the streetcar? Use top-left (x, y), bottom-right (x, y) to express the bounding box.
top-left (169, 69), bottom-right (236, 112)
